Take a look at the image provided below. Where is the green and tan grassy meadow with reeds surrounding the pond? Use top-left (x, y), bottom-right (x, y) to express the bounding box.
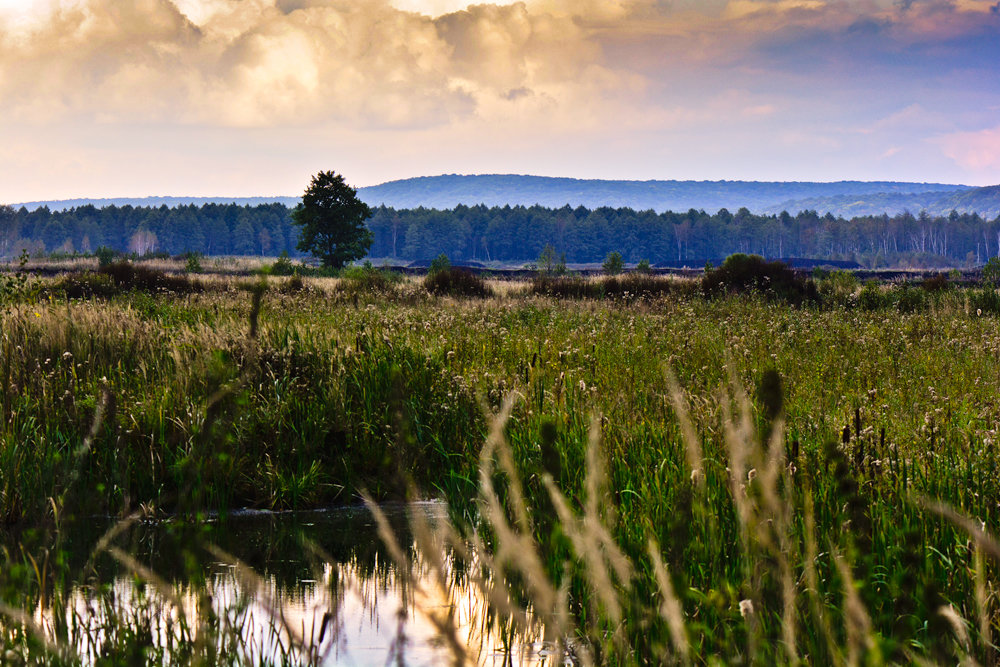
top-left (0, 260), bottom-right (1000, 665)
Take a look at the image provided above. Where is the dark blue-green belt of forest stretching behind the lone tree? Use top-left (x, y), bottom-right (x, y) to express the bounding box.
top-left (0, 203), bottom-right (1000, 265)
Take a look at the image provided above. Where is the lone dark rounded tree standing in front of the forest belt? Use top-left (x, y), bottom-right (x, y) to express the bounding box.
top-left (292, 171), bottom-right (372, 269)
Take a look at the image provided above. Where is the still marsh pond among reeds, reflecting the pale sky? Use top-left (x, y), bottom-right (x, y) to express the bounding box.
top-left (17, 502), bottom-right (552, 665)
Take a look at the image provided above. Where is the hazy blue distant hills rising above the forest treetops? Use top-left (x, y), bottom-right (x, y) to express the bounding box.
top-left (15, 174), bottom-right (1000, 218)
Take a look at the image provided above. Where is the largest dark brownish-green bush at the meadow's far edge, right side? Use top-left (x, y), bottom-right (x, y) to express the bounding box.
top-left (702, 253), bottom-right (819, 304)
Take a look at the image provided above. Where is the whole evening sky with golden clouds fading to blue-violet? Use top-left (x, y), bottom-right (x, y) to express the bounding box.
top-left (0, 0), bottom-right (1000, 203)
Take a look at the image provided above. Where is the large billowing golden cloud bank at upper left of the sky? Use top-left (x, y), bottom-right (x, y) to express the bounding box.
top-left (0, 0), bottom-right (635, 127)
